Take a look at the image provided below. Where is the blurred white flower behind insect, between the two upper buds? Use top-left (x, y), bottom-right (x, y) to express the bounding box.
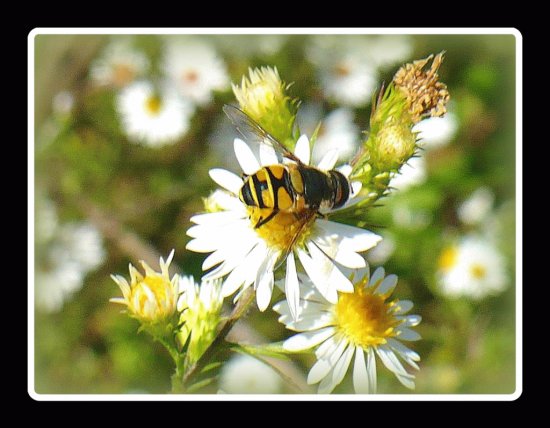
top-left (297, 104), bottom-right (360, 163)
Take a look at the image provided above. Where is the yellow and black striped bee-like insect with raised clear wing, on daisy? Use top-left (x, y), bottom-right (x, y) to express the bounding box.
top-left (223, 105), bottom-right (351, 229)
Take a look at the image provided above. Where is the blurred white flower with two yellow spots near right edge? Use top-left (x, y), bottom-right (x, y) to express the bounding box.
top-left (437, 234), bottom-right (508, 300)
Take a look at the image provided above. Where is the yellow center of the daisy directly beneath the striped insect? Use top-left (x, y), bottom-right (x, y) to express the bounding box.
top-left (248, 207), bottom-right (315, 251)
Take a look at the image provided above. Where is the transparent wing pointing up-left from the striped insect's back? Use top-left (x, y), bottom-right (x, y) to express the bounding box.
top-left (223, 104), bottom-right (302, 164)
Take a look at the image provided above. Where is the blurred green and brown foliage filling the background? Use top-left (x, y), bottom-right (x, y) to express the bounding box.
top-left (34, 35), bottom-right (515, 394)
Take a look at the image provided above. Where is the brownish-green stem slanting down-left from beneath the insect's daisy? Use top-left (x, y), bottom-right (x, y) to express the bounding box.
top-left (182, 287), bottom-right (255, 385)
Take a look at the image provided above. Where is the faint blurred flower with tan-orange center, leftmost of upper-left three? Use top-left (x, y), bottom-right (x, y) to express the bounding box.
top-left (90, 37), bottom-right (149, 88)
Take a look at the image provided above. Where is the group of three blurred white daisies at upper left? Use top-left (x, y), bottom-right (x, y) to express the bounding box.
top-left (90, 37), bottom-right (229, 147)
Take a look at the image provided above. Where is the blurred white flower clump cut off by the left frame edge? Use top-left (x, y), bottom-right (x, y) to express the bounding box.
top-left (34, 197), bottom-right (105, 312)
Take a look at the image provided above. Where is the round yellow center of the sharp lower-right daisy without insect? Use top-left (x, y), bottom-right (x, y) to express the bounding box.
top-left (335, 284), bottom-right (401, 348)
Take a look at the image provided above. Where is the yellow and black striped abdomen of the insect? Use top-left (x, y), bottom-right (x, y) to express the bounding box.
top-left (239, 165), bottom-right (296, 210)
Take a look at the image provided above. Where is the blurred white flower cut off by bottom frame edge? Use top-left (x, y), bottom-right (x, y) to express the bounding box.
top-left (219, 355), bottom-right (282, 394)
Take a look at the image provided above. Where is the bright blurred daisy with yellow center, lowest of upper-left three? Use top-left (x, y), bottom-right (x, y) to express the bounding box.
top-left (117, 81), bottom-right (193, 147)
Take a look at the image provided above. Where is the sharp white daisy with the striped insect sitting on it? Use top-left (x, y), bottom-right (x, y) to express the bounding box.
top-left (187, 135), bottom-right (381, 316)
